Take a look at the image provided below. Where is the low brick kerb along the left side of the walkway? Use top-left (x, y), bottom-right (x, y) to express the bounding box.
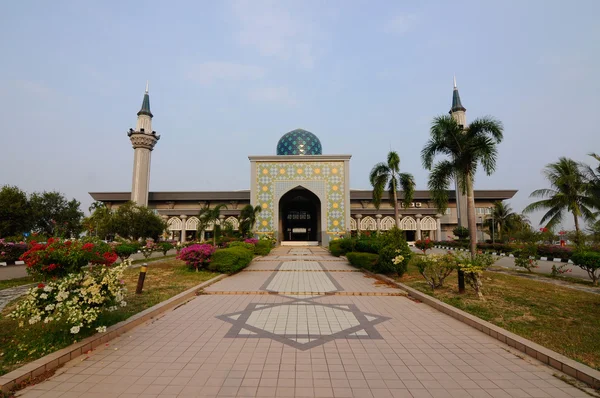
top-left (0, 274), bottom-right (228, 393)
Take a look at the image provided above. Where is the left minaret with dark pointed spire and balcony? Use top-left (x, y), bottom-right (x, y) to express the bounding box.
top-left (127, 82), bottom-right (160, 206)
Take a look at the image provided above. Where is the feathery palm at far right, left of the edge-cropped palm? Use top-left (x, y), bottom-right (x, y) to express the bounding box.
top-left (523, 157), bottom-right (595, 235)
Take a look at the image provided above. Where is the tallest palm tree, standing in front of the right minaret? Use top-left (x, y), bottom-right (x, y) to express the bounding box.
top-left (421, 115), bottom-right (503, 258)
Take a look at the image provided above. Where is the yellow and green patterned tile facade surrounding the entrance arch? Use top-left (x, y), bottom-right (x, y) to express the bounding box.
top-left (254, 162), bottom-right (347, 235)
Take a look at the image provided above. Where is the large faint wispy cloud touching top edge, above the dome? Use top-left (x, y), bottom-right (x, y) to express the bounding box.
top-left (233, 0), bottom-right (315, 68)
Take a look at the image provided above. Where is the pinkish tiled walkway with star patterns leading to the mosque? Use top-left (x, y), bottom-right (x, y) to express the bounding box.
top-left (21, 248), bottom-right (588, 398)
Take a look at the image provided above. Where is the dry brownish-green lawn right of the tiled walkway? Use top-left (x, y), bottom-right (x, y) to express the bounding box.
top-left (398, 264), bottom-right (600, 370)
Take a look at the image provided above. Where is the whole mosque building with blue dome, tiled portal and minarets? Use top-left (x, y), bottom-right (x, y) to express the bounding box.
top-left (90, 82), bottom-right (517, 246)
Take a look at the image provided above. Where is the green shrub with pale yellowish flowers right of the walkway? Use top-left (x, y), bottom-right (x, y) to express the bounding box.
top-left (377, 227), bottom-right (412, 276)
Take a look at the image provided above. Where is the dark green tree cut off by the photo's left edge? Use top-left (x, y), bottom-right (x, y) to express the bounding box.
top-left (0, 185), bottom-right (31, 238)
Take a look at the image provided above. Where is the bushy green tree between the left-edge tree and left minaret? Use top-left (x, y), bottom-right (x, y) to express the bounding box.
top-left (29, 191), bottom-right (83, 237)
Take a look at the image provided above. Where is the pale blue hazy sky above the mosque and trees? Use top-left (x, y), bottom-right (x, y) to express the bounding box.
top-left (0, 0), bottom-right (600, 226)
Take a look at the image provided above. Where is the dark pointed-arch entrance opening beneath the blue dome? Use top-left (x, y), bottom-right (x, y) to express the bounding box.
top-left (279, 187), bottom-right (321, 242)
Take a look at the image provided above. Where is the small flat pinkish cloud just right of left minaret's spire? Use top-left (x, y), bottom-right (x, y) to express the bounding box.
top-left (188, 62), bottom-right (265, 85)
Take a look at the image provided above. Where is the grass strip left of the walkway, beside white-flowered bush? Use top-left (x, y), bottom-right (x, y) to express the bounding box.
top-left (0, 260), bottom-right (218, 375)
